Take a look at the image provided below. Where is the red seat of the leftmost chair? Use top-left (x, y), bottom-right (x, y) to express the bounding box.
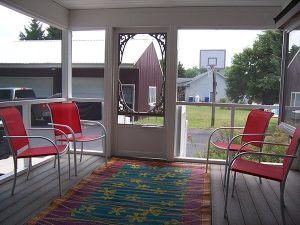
top-left (17, 145), bottom-right (67, 158)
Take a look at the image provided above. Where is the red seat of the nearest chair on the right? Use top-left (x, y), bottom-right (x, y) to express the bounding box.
top-left (231, 158), bottom-right (283, 182)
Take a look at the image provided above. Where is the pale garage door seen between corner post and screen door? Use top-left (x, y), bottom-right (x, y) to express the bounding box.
top-left (72, 77), bottom-right (104, 98)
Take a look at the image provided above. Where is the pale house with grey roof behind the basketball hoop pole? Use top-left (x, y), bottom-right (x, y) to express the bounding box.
top-left (177, 72), bottom-right (226, 102)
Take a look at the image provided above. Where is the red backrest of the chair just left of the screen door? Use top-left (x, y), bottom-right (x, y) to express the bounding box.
top-left (48, 102), bottom-right (82, 136)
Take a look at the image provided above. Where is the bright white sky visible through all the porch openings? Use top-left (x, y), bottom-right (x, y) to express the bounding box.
top-left (0, 5), bottom-right (300, 69)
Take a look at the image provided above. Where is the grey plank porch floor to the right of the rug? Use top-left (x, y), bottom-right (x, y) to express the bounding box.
top-left (211, 165), bottom-right (300, 225)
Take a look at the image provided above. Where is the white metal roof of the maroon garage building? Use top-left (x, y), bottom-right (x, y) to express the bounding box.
top-left (0, 39), bottom-right (151, 65)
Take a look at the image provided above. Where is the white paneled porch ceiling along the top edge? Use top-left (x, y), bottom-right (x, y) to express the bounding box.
top-left (52, 0), bottom-right (289, 9)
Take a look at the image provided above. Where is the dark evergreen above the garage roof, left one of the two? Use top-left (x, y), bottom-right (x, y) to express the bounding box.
top-left (19, 19), bottom-right (45, 40)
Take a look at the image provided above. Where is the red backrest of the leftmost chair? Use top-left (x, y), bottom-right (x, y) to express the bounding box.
top-left (0, 107), bottom-right (29, 152)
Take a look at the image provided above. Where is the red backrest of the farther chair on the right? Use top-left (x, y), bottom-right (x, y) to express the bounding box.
top-left (242, 109), bottom-right (273, 147)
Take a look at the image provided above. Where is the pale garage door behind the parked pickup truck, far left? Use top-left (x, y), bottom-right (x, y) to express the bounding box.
top-left (0, 77), bottom-right (53, 98)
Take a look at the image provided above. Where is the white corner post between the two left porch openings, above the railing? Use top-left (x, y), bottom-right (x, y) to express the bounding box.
top-left (61, 30), bottom-right (72, 98)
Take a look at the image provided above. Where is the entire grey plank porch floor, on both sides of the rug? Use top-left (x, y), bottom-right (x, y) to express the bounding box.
top-left (0, 155), bottom-right (300, 225)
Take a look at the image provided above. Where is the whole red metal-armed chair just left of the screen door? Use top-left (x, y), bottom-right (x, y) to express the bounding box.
top-left (48, 102), bottom-right (107, 176)
